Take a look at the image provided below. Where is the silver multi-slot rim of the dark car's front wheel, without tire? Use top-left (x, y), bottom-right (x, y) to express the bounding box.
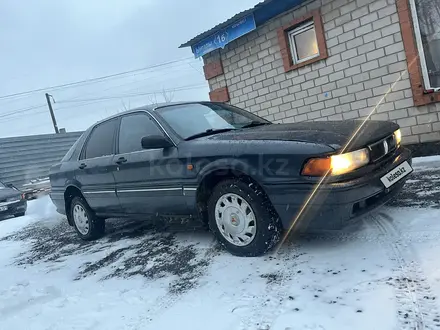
top-left (215, 193), bottom-right (257, 246)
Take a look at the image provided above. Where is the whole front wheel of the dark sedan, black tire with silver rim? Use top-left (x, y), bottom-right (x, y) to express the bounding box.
top-left (208, 179), bottom-right (282, 257)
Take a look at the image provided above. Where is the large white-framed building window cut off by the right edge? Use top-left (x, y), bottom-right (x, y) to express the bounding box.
top-left (410, 0), bottom-right (440, 91)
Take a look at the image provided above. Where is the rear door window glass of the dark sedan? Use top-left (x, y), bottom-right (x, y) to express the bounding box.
top-left (81, 118), bottom-right (118, 159)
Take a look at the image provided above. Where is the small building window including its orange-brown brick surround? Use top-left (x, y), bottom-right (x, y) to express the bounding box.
top-left (278, 11), bottom-right (327, 72)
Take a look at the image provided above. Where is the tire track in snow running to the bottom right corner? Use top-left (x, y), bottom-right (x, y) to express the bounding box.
top-left (371, 213), bottom-right (440, 330)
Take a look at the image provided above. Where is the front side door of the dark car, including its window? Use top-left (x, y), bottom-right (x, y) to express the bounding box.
top-left (115, 112), bottom-right (188, 214)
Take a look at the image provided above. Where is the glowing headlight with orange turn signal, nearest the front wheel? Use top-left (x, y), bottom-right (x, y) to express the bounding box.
top-left (301, 148), bottom-right (370, 176)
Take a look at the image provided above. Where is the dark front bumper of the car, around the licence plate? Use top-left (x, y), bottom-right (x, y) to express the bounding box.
top-left (264, 147), bottom-right (412, 231)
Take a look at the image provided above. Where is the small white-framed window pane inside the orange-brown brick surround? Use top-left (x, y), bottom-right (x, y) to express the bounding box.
top-left (288, 21), bottom-right (319, 64)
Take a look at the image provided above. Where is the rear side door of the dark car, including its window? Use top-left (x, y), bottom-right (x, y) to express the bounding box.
top-left (75, 118), bottom-right (121, 215)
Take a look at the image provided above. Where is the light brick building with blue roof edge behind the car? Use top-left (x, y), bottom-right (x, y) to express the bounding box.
top-left (181, 0), bottom-right (440, 143)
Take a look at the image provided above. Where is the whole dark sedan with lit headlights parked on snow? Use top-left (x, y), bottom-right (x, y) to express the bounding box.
top-left (50, 102), bottom-right (412, 256)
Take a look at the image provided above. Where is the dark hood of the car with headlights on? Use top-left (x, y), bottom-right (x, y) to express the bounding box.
top-left (208, 120), bottom-right (399, 150)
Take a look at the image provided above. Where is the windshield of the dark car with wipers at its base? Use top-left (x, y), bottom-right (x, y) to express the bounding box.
top-left (157, 103), bottom-right (270, 139)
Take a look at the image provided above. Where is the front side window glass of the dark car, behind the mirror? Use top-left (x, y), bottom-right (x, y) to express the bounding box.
top-left (119, 113), bottom-right (163, 154)
